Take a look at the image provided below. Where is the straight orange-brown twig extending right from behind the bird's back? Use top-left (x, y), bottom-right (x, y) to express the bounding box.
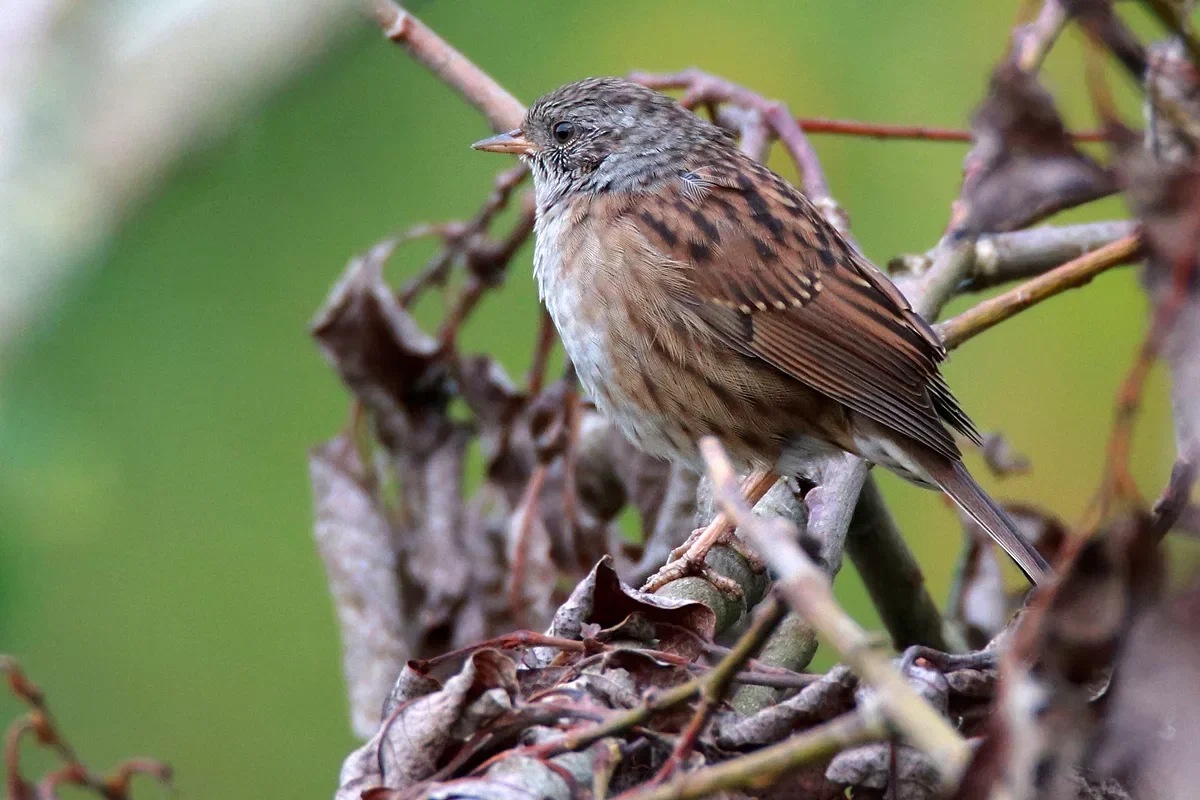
top-left (936, 227), bottom-right (1141, 349)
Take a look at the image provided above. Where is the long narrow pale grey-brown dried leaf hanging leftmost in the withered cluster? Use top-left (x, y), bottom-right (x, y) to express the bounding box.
top-left (308, 434), bottom-right (412, 739)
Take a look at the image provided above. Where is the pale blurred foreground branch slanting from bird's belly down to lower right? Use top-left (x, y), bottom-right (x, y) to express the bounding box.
top-left (700, 437), bottom-right (970, 787)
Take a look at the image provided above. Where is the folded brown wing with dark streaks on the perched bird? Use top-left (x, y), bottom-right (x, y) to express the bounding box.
top-left (632, 154), bottom-right (978, 458)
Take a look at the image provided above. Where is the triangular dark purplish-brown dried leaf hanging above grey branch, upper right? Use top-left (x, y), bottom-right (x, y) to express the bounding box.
top-left (953, 64), bottom-right (1115, 235)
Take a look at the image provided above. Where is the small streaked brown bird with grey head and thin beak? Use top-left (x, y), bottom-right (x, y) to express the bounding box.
top-left (474, 78), bottom-right (1048, 583)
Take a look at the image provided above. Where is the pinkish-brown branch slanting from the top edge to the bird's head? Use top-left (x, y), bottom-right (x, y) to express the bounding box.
top-left (367, 0), bottom-right (524, 132)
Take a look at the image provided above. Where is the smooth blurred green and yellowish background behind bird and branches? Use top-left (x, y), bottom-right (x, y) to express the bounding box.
top-left (0, 0), bottom-right (1174, 798)
